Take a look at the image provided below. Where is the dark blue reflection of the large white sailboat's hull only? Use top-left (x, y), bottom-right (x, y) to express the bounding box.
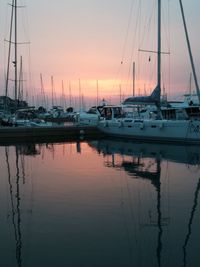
top-left (90, 139), bottom-right (200, 165)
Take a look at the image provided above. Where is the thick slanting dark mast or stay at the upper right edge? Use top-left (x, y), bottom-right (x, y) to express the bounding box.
top-left (179, 0), bottom-right (200, 104)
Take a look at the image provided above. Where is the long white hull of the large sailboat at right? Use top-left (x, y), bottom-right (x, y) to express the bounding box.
top-left (98, 119), bottom-right (200, 143)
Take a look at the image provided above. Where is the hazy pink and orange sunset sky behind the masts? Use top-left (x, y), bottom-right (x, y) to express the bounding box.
top-left (0, 0), bottom-right (200, 109)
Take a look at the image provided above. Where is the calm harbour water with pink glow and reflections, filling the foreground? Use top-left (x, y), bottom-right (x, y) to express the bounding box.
top-left (0, 140), bottom-right (200, 267)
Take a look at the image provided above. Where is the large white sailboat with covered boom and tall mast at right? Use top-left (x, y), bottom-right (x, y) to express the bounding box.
top-left (98, 0), bottom-right (200, 143)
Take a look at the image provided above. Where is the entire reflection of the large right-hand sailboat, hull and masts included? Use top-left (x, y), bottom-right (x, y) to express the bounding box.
top-left (89, 139), bottom-right (200, 267)
